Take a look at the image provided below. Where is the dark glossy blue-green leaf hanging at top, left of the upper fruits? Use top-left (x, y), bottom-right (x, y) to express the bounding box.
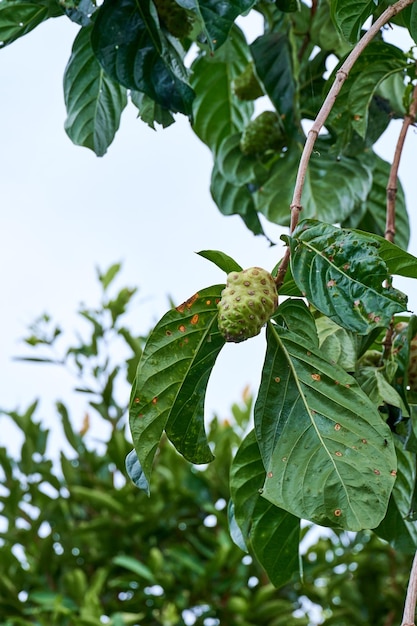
top-left (91, 0), bottom-right (194, 116)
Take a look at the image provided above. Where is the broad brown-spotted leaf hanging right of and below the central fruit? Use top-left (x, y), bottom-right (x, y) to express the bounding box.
top-left (255, 323), bottom-right (396, 530)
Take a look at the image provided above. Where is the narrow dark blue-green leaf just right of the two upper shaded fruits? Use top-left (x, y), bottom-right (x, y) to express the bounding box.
top-left (250, 32), bottom-right (298, 128)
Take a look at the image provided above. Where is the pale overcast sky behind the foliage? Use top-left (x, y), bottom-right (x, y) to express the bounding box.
top-left (0, 18), bottom-right (417, 450)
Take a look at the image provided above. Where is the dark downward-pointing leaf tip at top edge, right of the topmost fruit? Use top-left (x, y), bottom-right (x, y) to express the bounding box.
top-left (176, 0), bottom-right (256, 50)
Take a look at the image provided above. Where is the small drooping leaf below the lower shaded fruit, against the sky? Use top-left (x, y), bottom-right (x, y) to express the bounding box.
top-left (210, 165), bottom-right (264, 235)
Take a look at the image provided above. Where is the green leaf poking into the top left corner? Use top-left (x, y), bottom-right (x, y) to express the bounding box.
top-left (0, 0), bottom-right (63, 48)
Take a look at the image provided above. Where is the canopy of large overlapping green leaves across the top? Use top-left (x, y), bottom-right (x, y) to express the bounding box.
top-left (0, 0), bottom-right (417, 238)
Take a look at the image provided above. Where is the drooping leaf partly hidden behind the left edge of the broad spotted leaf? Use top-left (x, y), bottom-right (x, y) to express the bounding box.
top-left (230, 430), bottom-right (300, 587)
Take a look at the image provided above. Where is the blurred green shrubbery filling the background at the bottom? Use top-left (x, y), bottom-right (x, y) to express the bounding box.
top-left (0, 266), bottom-right (410, 626)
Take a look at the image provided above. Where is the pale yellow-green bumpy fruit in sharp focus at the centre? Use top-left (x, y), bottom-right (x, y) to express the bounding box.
top-left (217, 267), bottom-right (278, 343)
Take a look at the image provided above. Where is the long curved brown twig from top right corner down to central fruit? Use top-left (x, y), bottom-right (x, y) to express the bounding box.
top-left (275, 0), bottom-right (415, 289)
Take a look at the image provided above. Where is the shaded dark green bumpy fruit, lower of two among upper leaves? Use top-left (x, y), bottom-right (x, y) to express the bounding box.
top-left (240, 111), bottom-right (286, 156)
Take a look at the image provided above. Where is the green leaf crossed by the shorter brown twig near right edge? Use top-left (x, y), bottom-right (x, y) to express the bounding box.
top-left (342, 155), bottom-right (410, 250)
